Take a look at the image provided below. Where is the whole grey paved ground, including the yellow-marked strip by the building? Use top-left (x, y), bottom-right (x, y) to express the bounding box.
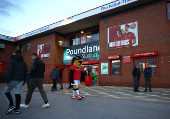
top-left (0, 84), bottom-right (170, 119)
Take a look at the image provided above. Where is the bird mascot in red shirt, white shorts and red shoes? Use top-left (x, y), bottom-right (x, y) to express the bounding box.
top-left (69, 56), bottom-right (85, 100)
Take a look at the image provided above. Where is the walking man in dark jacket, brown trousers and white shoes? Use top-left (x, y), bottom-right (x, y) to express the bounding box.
top-left (20, 53), bottom-right (50, 108)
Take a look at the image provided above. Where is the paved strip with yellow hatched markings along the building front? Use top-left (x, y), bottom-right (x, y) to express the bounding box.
top-left (0, 84), bottom-right (170, 102)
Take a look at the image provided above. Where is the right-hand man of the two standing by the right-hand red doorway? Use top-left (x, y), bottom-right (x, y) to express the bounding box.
top-left (144, 63), bottom-right (152, 92)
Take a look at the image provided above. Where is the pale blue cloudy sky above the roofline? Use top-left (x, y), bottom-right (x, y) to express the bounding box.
top-left (0, 0), bottom-right (115, 37)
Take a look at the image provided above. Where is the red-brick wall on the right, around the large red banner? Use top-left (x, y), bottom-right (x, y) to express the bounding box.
top-left (99, 3), bottom-right (170, 88)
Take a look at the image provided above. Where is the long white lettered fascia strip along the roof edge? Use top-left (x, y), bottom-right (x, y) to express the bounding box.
top-left (15, 0), bottom-right (138, 41)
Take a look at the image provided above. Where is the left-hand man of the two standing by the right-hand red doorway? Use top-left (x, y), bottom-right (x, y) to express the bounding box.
top-left (132, 64), bottom-right (141, 92)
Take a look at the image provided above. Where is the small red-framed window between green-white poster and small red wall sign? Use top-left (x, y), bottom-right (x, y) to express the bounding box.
top-left (111, 60), bottom-right (120, 75)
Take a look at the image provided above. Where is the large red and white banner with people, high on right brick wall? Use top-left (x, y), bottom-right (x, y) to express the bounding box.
top-left (108, 22), bottom-right (138, 49)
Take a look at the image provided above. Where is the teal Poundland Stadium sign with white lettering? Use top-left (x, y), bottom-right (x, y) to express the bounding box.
top-left (63, 41), bottom-right (99, 65)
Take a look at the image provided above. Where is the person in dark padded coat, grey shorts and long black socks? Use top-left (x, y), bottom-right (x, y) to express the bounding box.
top-left (4, 50), bottom-right (27, 114)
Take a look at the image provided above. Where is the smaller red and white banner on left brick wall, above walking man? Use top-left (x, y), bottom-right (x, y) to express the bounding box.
top-left (37, 43), bottom-right (50, 59)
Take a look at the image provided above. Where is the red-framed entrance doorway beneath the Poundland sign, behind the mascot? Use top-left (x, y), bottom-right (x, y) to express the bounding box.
top-left (82, 64), bottom-right (99, 84)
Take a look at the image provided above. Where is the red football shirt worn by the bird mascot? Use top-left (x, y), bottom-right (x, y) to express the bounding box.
top-left (70, 65), bottom-right (81, 80)
